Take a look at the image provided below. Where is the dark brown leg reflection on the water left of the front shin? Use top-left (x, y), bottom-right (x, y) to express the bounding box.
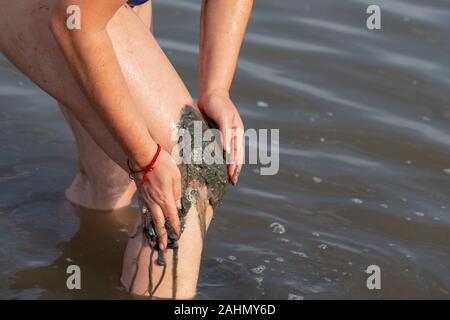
top-left (10, 205), bottom-right (137, 299)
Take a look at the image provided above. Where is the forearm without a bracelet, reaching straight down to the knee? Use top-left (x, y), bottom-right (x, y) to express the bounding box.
top-left (199, 0), bottom-right (253, 98)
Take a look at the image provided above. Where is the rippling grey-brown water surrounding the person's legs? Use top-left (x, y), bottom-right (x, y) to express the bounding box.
top-left (0, 0), bottom-right (450, 299)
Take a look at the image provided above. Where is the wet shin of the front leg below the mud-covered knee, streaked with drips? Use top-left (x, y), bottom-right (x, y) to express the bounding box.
top-left (121, 198), bottom-right (213, 299)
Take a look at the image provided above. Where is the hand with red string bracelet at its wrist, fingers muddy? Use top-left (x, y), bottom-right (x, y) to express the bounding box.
top-left (129, 149), bottom-right (181, 250)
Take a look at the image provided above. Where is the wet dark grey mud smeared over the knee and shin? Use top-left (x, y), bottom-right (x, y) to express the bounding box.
top-left (130, 105), bottom-right (228, 298)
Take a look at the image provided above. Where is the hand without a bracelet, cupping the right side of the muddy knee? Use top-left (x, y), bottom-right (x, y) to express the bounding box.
top-left (198, 92), bottom-right (244, 185)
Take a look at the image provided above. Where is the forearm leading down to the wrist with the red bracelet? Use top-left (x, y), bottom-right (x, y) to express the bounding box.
top-left (52, 1), bottom-right (156, 166)
